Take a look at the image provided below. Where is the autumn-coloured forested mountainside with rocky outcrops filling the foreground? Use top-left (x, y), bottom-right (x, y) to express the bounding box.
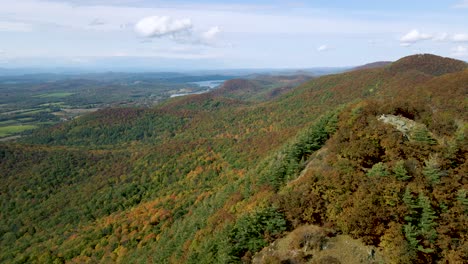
top-left (0, 54), bottom-right (468, 263)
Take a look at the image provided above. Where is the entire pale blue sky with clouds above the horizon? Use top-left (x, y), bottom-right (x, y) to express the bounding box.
top-left (0, 0), bottom-right (468, 70)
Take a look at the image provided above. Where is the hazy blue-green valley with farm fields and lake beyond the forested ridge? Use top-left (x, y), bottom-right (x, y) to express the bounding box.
top-left (0, 73), bottom-right (234, 141)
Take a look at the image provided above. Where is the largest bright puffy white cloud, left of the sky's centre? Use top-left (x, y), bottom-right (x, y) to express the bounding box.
top-left (135, 16), bottom-right (193, 38)
